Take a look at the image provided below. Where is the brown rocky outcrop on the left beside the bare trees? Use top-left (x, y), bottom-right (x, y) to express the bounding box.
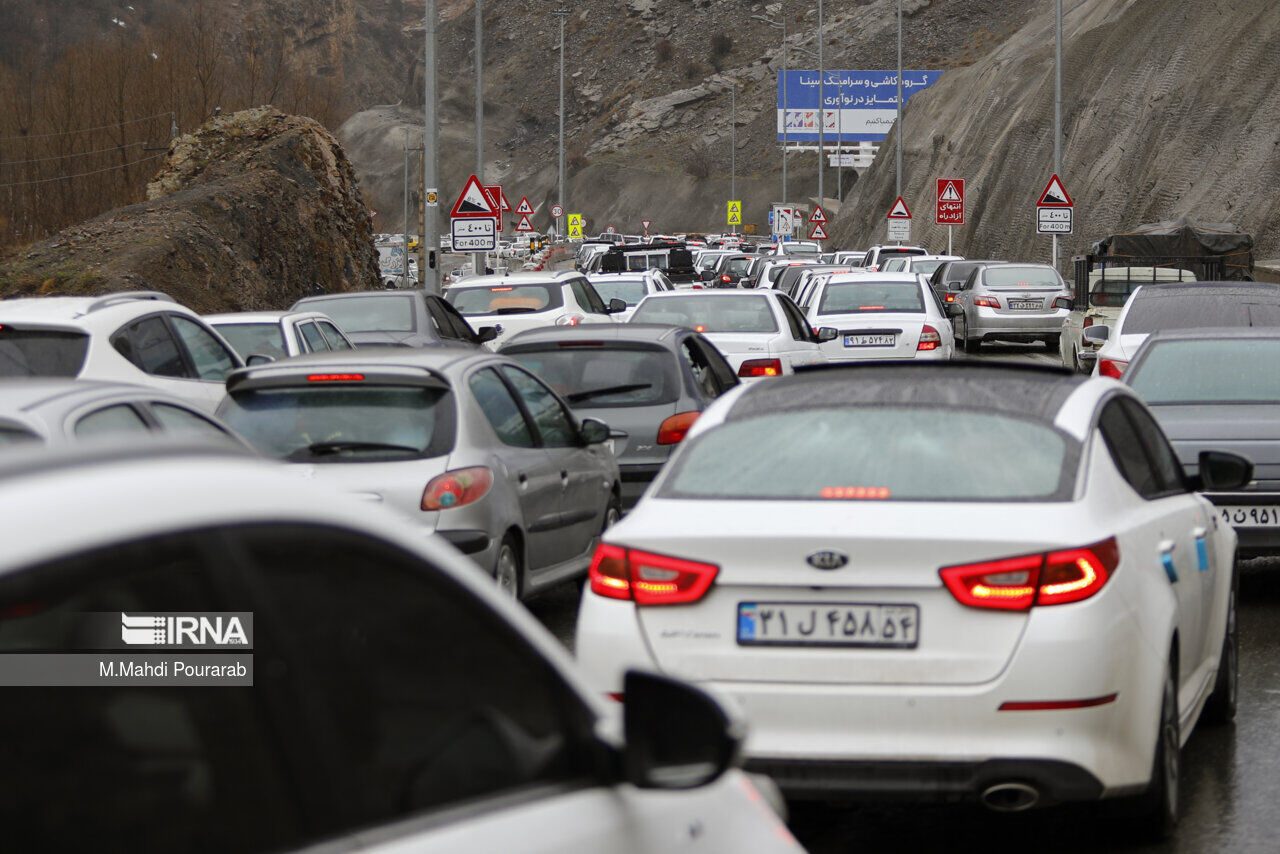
top-left (0, 108), bottom-right (379, 312)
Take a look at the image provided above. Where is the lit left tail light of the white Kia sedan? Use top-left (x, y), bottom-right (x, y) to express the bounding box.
top-left (589, 543), bottom-right (719, 604)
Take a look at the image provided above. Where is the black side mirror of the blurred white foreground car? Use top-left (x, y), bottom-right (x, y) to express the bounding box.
top-left (622, 670), bottom-right (745, 789)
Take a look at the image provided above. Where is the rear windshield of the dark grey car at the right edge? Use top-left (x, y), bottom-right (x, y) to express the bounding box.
top-left (1125, 338), bottom-right (1280, 406)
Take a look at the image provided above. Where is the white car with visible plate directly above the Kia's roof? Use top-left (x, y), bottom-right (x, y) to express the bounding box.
top-left (801, 273), bottom-right (955, 362)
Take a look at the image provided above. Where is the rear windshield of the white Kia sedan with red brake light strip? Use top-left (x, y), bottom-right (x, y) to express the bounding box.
top-left (659, 406), bottom-right (1079, 502)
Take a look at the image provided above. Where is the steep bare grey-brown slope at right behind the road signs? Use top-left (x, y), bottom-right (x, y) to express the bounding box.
top-left (832, 0), bottom-right (1280, 260)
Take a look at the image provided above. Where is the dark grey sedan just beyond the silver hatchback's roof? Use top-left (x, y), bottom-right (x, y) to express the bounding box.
top-left (291, 291), bottom-right (497, 347)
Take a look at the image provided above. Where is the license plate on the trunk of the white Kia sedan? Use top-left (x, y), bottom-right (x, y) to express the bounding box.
top-left (737, 602), bottom-right (920, 649)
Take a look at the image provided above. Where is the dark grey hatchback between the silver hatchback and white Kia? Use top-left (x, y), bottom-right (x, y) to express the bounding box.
top-left (499, 323), bottom-right (739, 510)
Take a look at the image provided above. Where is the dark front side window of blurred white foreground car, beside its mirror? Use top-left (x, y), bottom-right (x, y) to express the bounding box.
top-left (231, 526), bottom-right (598, 830)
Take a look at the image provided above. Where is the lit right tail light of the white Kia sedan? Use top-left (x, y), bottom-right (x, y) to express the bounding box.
top-left (938, 538), bottom-right (1120, 611)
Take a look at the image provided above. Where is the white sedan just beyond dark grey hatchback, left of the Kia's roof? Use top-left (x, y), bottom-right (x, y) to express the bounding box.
top-left (628, 289), bottom-right (836, 379)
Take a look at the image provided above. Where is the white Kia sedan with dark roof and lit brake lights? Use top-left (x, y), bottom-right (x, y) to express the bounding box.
top-left (577, 362), bottom-right (1252, 836)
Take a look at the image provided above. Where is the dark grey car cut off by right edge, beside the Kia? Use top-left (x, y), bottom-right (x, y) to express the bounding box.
top-left (1120, 328), bottom-right (1280, 557)
